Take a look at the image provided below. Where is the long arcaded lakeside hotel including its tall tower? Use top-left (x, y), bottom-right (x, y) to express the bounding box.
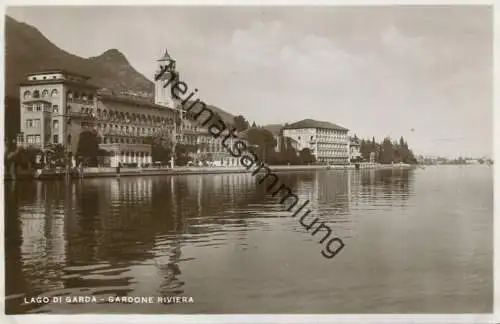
top-left (17, 51), bottom-right (239, 166)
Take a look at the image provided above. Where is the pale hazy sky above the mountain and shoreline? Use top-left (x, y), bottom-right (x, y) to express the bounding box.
top-left (7, 6), bottom-right (493, 156)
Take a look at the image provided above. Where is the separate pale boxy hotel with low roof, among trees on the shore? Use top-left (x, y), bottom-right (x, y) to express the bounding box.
top-left (283, 127), bottom-right (350, 164)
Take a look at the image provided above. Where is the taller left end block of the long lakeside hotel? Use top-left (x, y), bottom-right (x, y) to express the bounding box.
top-left (17, 70), bottom-right (97, 167)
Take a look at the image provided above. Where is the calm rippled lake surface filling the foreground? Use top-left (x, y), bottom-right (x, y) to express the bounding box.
top-left (5, 166), bottom-right (493, 314)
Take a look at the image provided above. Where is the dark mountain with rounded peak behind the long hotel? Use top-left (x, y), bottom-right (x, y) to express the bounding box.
top-left (5, 16), bottom-right (234, 138)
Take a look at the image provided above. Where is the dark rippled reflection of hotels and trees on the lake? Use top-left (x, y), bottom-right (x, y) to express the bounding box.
top-left (5, 170), bottom-right (413, 311)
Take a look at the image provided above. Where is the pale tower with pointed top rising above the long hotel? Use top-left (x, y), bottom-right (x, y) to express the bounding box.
top-left (155, 49), bottom-right (179, 108)
